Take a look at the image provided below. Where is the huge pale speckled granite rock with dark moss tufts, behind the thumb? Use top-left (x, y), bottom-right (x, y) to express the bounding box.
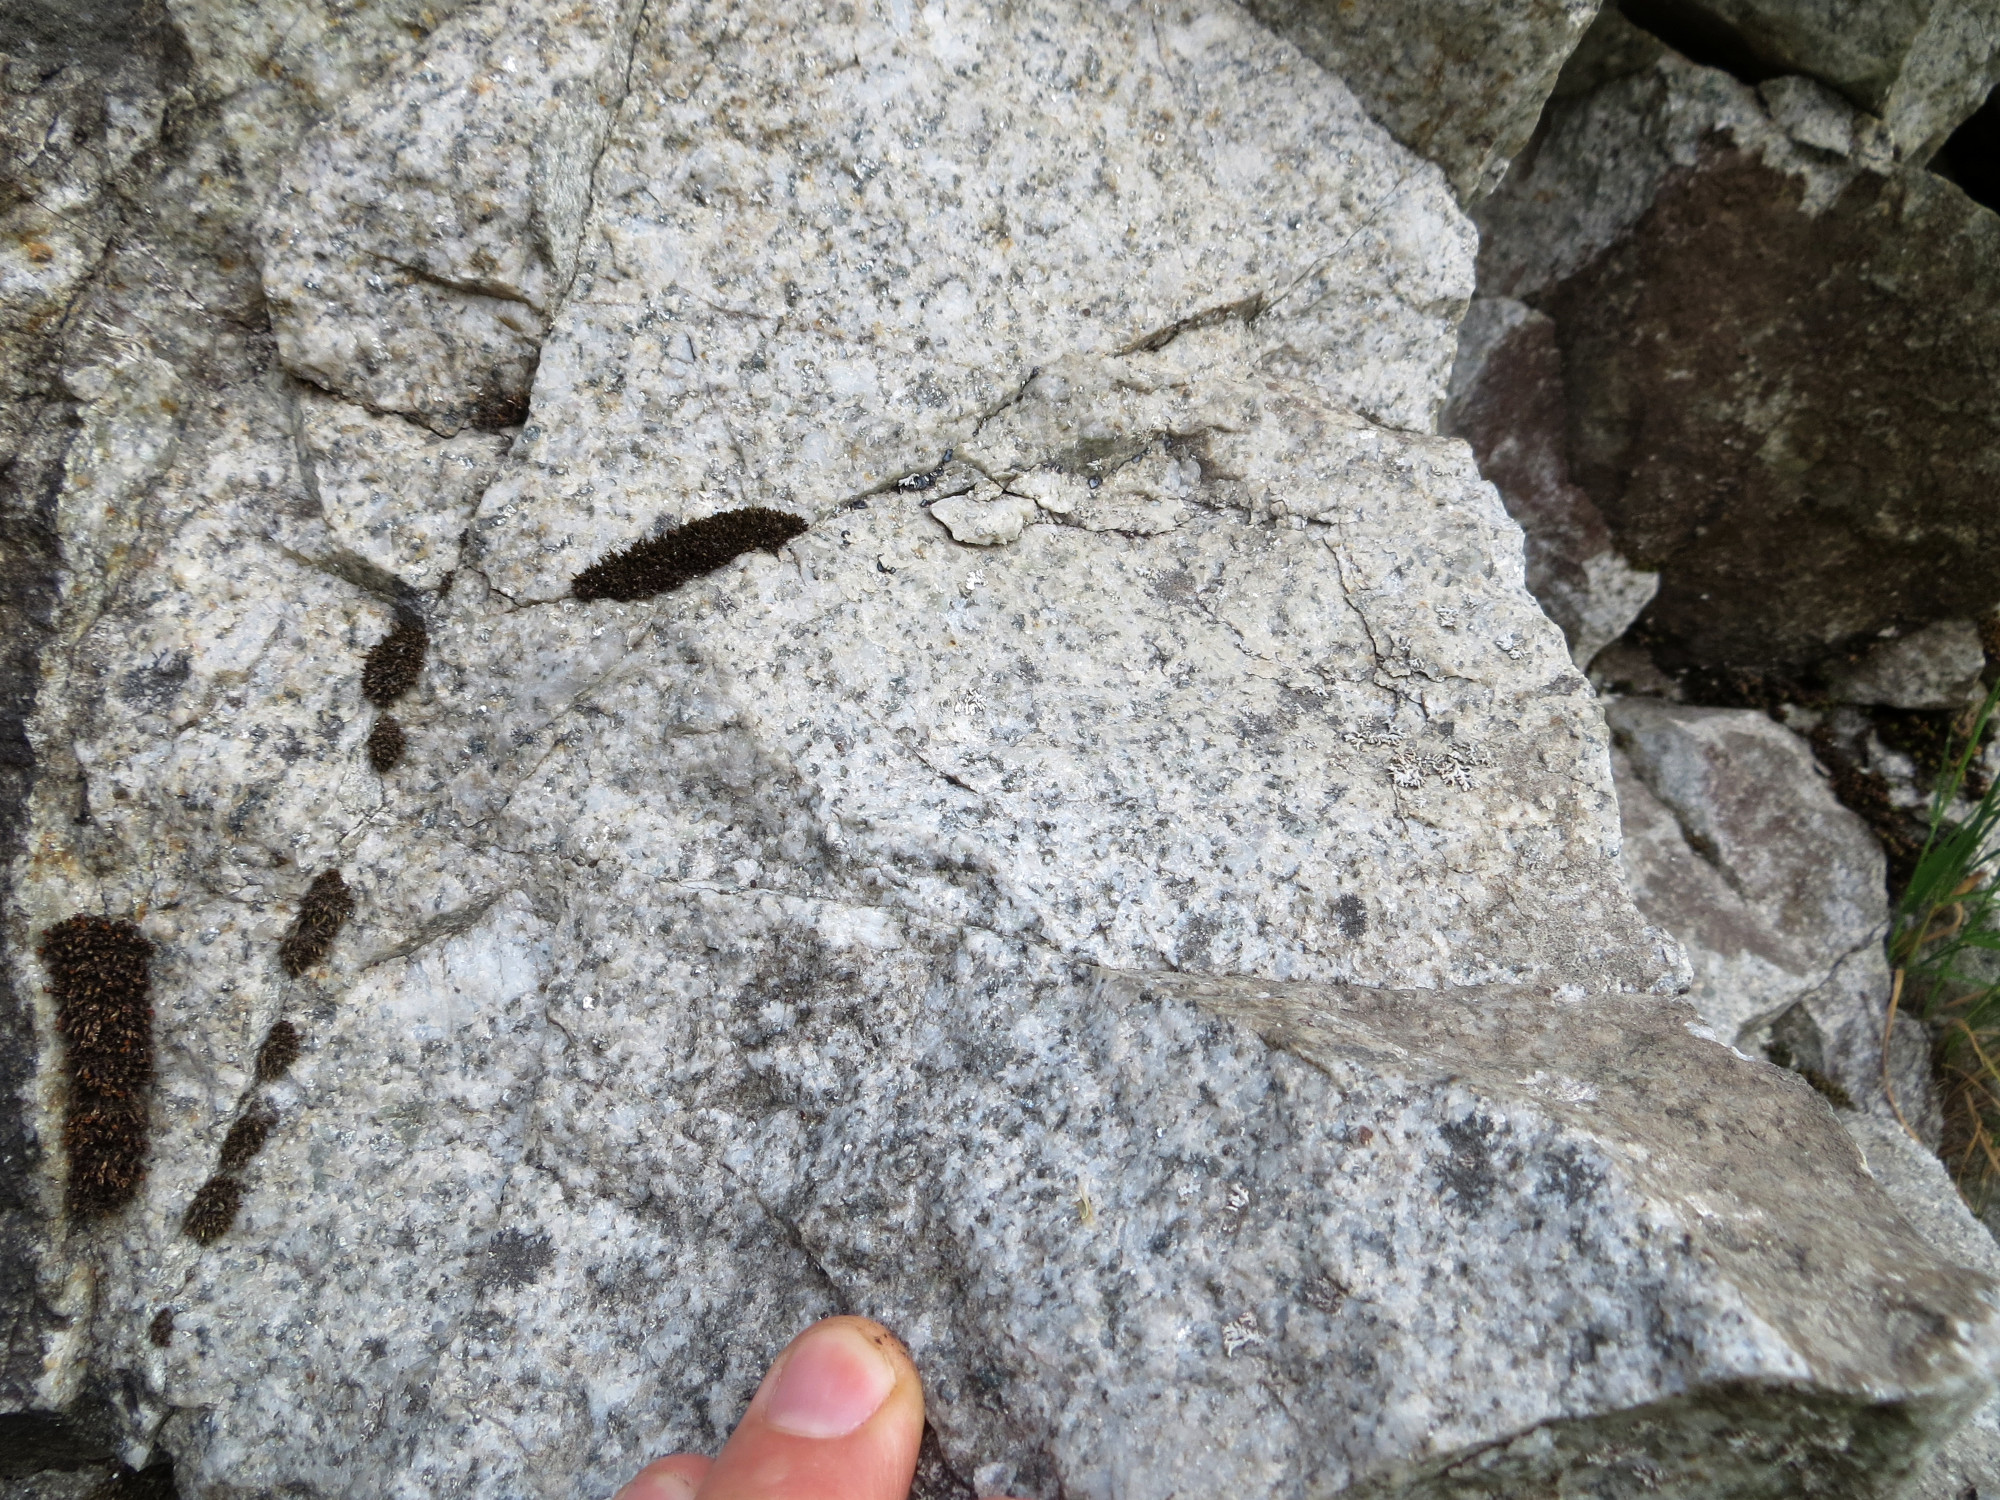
top-left (6, 0), bottom-right (1996, 1500)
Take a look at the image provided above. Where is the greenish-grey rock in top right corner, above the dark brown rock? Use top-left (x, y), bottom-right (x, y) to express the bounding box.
top-left (1630, 0), bottom-right (2000, 162)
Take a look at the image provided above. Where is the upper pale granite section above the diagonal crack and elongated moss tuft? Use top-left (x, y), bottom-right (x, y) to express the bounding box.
top-left (464, 0), bottom-right (1476, 600)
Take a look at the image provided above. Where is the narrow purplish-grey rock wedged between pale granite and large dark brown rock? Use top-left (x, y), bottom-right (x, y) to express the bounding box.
top-left (1440, 298), bottom-right (1660, 668)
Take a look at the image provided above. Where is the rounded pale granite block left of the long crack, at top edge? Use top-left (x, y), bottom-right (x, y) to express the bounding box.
top-left (262, 0), bottom-right (640, 436)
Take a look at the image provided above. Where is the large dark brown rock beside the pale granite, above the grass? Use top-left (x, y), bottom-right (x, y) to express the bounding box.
top-left (1480, 54), bottom-right (2000, 674)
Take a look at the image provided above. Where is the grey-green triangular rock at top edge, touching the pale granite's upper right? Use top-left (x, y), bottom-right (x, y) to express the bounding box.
top-left (1224, 0), bottom-right (1600, 198)
